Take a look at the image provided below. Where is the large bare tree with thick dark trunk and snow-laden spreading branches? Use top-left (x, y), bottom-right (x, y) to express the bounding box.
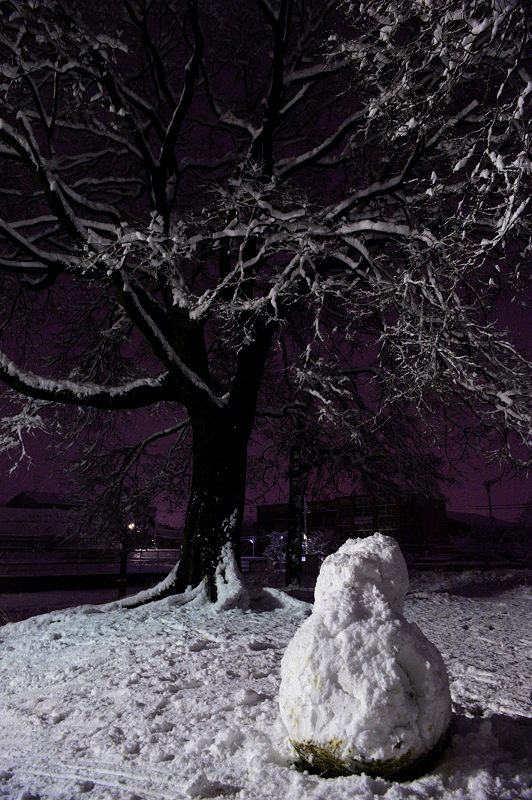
top-left (0, 0), bottom-right (532, 599)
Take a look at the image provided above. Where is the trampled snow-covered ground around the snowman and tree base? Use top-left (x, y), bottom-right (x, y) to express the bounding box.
top-left (0, 575), bottom-right (532, 800)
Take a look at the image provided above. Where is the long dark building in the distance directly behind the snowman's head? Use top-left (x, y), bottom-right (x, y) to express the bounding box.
top-left (255, 495), bottom-right (447, 550)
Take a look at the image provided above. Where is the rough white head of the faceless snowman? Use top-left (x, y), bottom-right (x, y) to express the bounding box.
top-left (314, 533), bottom-right (408, 613)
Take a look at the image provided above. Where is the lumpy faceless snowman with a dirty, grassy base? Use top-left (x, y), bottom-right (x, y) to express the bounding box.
top-left (279, 533), bottom-right (451, 777)
